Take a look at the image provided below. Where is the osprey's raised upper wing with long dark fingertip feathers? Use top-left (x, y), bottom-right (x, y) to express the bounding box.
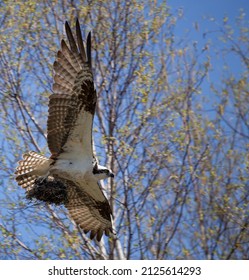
top-left (47, 19), bottom-right (97, 159)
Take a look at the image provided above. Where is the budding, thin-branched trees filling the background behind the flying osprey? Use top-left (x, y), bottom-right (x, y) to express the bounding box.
top-left (0, 0), bottom-right (249, 259)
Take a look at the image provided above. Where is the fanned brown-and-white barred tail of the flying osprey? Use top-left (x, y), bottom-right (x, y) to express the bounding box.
top-left (15, 151), bottom-right (51, 191)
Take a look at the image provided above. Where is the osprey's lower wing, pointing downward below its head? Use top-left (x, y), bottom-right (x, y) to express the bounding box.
top-left (65, 182), bottom-right (112, 241)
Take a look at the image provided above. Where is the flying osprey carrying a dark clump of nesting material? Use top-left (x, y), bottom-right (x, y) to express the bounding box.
top-left (15, 19), bottom-right (114, 241)
